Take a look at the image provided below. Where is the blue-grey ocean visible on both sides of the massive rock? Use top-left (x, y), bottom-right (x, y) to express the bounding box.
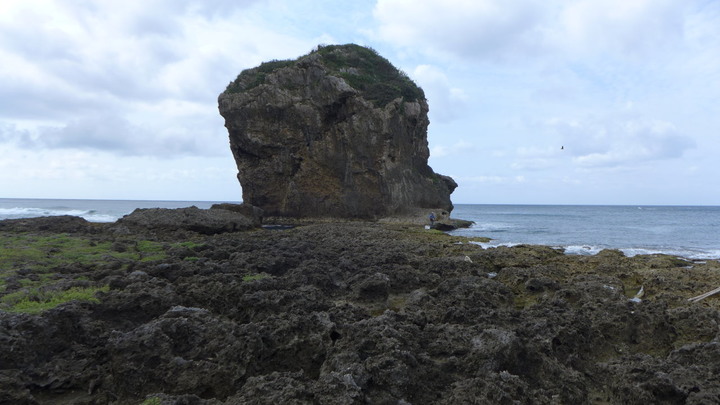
top-left (0, 198), bottom-right (720, 260)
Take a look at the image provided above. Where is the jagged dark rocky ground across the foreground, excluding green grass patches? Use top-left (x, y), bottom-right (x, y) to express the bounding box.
top-left (0, 215), bottom-right (720, 405)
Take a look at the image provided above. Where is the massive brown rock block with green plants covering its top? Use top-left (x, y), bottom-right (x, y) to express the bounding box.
top-left (218, 45), bottom-right (457, 218)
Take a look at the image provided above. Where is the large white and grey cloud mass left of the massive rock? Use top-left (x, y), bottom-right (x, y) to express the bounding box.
top-left (0, 0), bottom-right (312, 158)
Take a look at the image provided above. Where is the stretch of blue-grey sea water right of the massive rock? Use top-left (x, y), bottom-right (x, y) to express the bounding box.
top-left (452, 205), bottom-right (720, 260)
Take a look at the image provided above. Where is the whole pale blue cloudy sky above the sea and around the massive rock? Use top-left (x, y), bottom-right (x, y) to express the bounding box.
top-left (0, 0), bottom-right (720, 205)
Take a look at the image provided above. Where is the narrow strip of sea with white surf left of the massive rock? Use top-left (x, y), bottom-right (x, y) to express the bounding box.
top-left (0, 198), bottom-right (236, 222)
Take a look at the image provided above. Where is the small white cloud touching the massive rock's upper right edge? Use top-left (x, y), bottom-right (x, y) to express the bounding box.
top-left (412, 65), bottom-right (468, 122)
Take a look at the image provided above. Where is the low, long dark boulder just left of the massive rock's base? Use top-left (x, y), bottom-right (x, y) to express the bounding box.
top-left (116, 207), bottom-right (257, 235)
